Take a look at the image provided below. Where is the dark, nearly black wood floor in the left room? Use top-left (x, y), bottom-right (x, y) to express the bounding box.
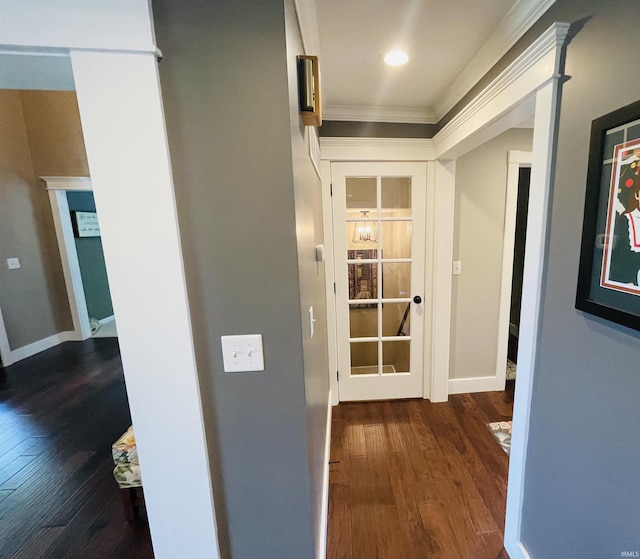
top-left (0, 338), bottom-right (153, 559)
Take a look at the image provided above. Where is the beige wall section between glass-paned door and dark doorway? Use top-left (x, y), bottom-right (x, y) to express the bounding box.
top-left (450, 128), bottom-right (533, 379)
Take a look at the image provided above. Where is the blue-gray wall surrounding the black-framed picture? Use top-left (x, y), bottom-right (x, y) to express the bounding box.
top-left (522, 0), bottom-right (640, 559)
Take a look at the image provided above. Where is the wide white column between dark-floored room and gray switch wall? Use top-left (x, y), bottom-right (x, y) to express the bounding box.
top-left (71, 51), bottom-right (219, 559)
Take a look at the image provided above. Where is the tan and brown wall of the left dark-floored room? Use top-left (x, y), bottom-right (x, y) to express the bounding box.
top-left (0, 90), bottom-right (88, 350)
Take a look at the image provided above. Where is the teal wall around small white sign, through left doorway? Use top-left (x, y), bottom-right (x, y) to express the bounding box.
top-left (67, 192), bottom-right (113, 320)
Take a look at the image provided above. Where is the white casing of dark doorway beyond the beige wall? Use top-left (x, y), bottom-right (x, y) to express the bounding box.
top-left (496, 151), bottom-right (532, 388)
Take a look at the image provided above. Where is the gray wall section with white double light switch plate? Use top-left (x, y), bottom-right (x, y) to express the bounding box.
top-left (153, 0), bottom-right (328, 559)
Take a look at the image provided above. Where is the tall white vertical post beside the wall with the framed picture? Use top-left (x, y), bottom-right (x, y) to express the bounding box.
top-left (504, 77), bottom-right (560, 556)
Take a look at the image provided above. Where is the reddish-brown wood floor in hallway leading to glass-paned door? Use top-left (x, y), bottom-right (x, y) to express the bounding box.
top-left (327, 386), bottom-right (513, 559)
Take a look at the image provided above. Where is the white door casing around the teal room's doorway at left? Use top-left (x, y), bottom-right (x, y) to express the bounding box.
top-left (42, 187), bottom-right (91, 340)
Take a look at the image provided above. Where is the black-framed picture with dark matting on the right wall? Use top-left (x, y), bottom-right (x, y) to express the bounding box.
top-left (576, 101), bottom-right (640, 330)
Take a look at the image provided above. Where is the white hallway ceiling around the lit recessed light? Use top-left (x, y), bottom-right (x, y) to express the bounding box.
top-left (315, 0), bottom-right (554, 123)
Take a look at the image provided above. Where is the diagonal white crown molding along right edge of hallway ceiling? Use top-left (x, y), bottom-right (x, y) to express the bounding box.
top-left (435, 0), bottom-right (555, 118)
